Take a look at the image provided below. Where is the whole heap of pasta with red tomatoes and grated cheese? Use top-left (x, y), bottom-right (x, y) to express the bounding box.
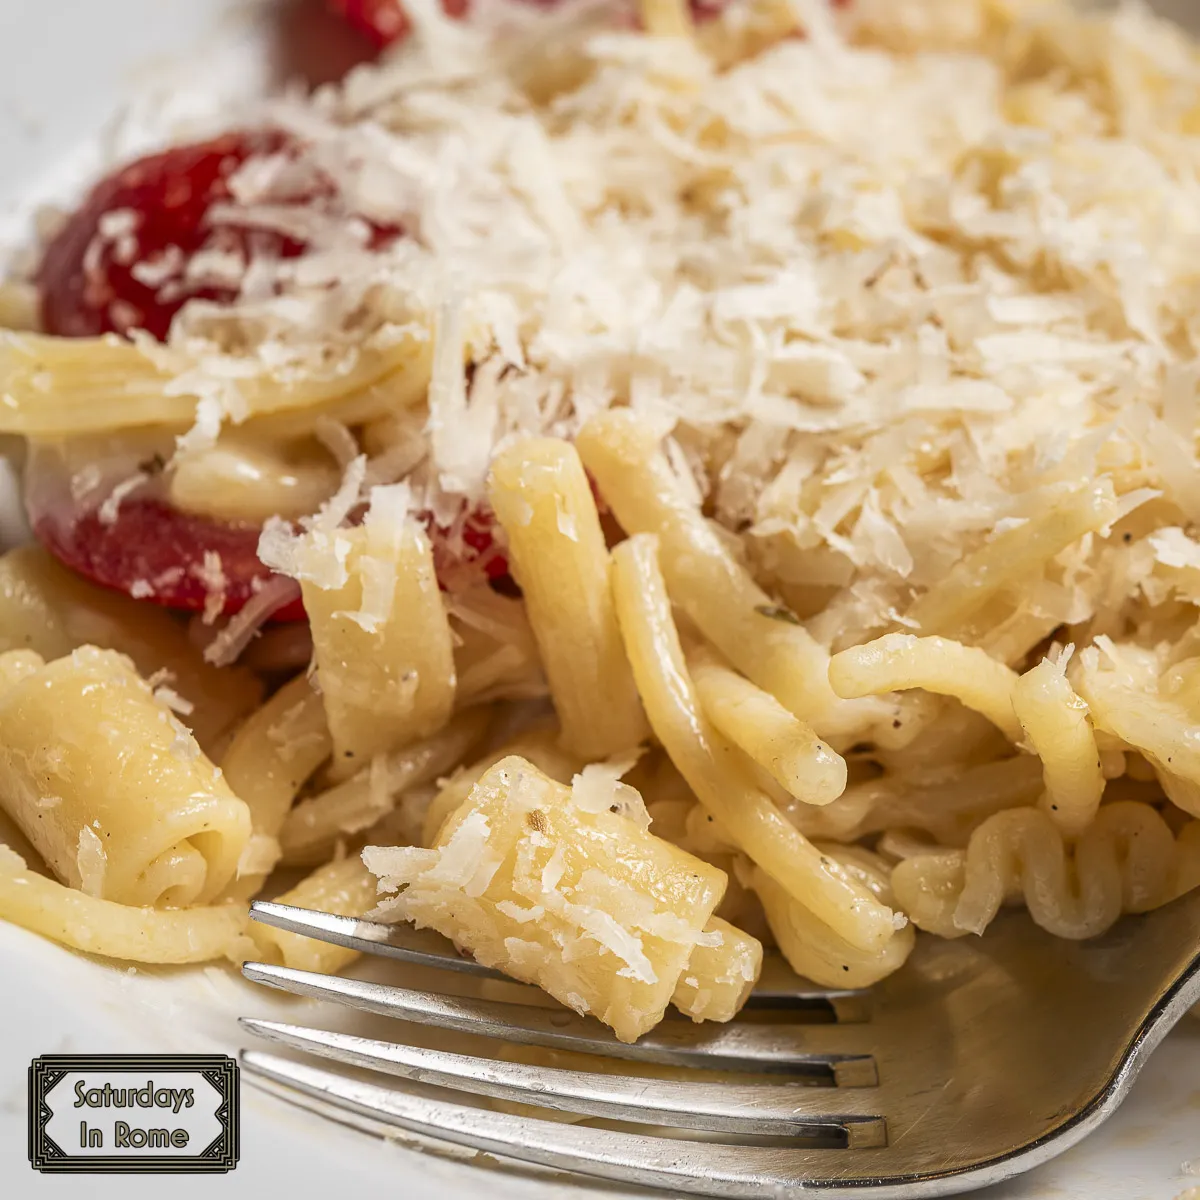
top-left (0, 0), bottom-right (1200, 1038)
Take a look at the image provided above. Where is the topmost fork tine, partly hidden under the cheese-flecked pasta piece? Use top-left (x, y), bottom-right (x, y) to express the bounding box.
top-left (250, 900), bottom-right (870, 1024)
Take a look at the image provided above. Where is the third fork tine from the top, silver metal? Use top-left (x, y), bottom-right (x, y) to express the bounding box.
top-left (241, 1018), bottom-right (887, 1148)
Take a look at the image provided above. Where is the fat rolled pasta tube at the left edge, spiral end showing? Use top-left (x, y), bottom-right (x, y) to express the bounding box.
top-left (0, 646), bottom-right (251, 907)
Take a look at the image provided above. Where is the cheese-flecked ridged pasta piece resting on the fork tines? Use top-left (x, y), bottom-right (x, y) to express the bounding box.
top-left (364, 757), bottom-right (748, 1042)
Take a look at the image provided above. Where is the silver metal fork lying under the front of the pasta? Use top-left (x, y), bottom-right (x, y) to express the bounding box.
top-left (242, 892), bottom-right (1200, 1200)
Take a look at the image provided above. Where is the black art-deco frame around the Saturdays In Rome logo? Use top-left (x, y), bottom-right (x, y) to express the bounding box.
top-left (29, 1054), bottom-right (241, 1175)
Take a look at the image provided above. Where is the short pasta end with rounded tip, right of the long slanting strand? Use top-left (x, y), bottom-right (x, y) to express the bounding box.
top-left (688, 650), bottom-right (846, 804)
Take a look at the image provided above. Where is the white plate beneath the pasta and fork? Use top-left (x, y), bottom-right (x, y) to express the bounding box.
top-left (0, 0), bottom-right (1200, 1200)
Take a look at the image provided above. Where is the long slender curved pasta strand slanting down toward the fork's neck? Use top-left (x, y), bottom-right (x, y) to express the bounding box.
top-left (613, 534), bottom-right (895, 949)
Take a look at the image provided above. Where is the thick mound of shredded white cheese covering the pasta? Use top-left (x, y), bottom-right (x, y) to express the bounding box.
top-left (82, 0), bottom-right (1200, 676)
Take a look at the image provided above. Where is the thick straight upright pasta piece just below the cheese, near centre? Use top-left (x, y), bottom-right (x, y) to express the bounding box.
top-left (488, 438), bottom-right (648, 758)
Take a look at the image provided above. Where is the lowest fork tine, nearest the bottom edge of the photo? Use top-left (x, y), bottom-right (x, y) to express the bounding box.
top-left (241, 1050), bottom-right (883, 1200)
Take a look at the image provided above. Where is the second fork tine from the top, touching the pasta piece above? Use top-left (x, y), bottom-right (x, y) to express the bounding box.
top-left (242, 962), bottom-right (878, 1087)
